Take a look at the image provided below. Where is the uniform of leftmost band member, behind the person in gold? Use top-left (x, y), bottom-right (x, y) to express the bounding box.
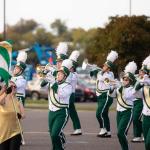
top-left (11, 75), bottom-right (27, 106)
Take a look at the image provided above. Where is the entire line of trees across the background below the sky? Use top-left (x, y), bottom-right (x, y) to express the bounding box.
top-left (4, 16), bottom-right (150, 71)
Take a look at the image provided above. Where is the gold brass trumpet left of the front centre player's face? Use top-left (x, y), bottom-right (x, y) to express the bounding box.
top-left (36, 63), bottom-right (57, 77)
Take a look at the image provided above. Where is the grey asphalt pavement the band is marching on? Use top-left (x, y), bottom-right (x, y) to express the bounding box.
top-left (21, 109), bottom-right (144, 150)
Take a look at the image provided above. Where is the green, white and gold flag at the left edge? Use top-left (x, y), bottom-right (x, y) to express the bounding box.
top-left (0, 41), bottom-right (12, 85)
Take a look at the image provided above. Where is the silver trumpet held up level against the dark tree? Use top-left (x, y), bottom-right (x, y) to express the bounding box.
top-left (82, 59), bottom-right (102, 71)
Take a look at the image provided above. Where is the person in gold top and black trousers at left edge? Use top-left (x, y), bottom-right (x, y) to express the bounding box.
top-left (0, 81), bottom-right (24, 150)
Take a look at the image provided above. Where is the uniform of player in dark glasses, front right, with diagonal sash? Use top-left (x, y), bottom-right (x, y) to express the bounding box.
top-left (111, 86), bottom-right (135, 150)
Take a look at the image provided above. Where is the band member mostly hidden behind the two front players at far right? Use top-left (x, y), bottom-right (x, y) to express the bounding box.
top-left (132, 57), bottom-right (148, 142)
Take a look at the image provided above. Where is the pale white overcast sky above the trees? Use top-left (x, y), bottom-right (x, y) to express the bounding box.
top-left (0, 0), bottom-right (150, 32)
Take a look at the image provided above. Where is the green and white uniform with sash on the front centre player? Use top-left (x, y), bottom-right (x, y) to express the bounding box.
top-left (48, 82), bottom-right (72, 150)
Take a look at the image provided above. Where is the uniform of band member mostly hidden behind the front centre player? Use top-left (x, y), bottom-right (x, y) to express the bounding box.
top-left (67, 72), bottom-right (81, 130)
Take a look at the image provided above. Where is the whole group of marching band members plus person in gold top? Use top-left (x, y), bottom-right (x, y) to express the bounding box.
top-left (0, 41), bottom-right (150, 150)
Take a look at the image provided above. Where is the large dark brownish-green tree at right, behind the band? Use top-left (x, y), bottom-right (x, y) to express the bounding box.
top-left (86, 16), bottom-right (150, 70)
